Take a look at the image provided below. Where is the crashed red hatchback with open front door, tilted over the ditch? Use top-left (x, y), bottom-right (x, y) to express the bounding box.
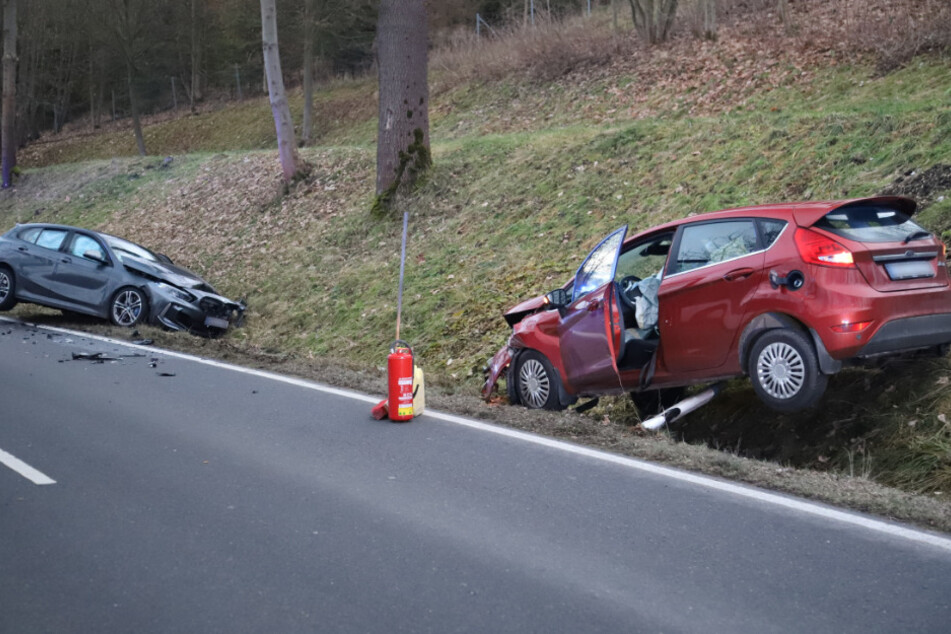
top-left (482, 196), bottom-right (951, 412)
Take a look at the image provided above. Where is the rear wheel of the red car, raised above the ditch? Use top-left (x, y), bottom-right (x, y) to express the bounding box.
top-left (748, 328), bottom-right (828, 412)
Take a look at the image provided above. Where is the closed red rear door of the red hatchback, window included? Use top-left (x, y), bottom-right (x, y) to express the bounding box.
top-left (658, 218), bottom-right (764, 373)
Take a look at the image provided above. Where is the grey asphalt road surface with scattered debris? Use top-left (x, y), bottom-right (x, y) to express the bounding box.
top-left (0, 321), bottom-right (951, 633)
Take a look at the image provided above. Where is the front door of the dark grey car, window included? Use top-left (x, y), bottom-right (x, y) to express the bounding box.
top-left (50, 232), bottom-right (115, 314)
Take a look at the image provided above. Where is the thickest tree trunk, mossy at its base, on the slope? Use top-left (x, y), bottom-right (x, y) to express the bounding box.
top-left (376, 0), bottom-right (432, 203)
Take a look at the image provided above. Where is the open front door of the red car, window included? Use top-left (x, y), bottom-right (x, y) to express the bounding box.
top-left (558, 225), bottom-right (627, 393)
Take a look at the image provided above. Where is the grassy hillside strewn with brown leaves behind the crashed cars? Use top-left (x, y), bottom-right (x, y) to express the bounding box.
top-left (0, 3), bottom-right (951, 530)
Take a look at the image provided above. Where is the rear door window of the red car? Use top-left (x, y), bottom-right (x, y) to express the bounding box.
top-left (672, 220), bottom-right (757, 273)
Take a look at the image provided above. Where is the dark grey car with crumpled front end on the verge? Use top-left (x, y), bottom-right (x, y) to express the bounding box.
top-left (0, 223), bottom-right (245, 337)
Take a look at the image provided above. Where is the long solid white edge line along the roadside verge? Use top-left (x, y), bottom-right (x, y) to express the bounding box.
top-left (0, 317), bottom-right (951, 552)
